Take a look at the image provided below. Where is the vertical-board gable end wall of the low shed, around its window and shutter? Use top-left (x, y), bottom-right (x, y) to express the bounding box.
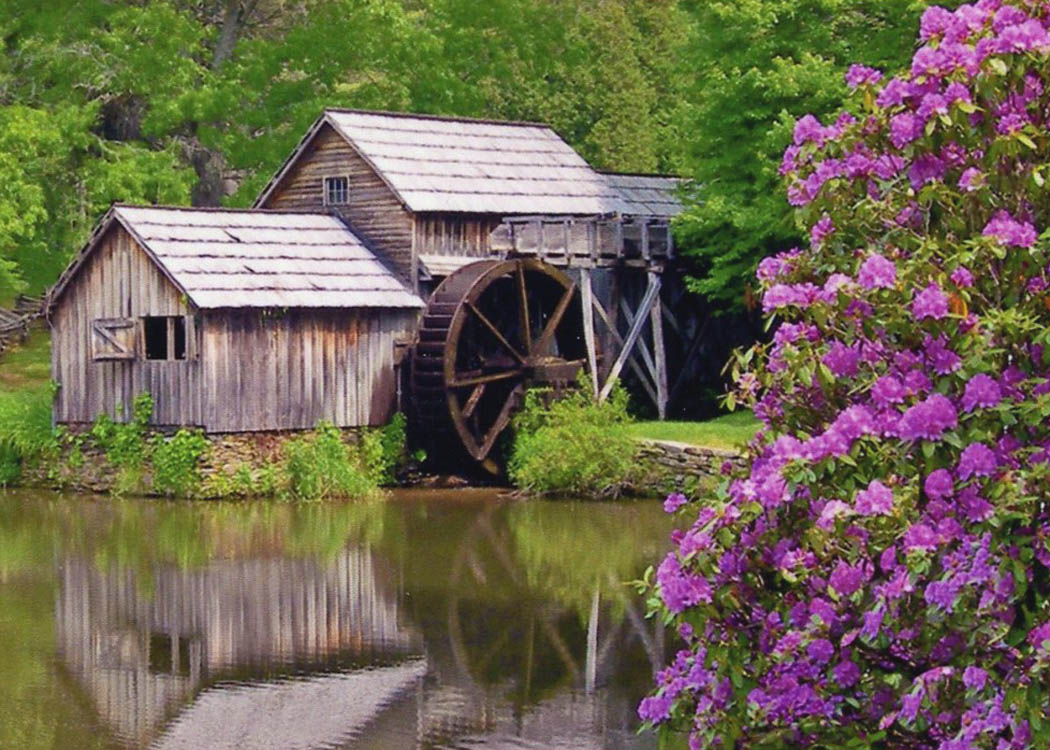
top-left (51, 225), bottom-right (202, 425)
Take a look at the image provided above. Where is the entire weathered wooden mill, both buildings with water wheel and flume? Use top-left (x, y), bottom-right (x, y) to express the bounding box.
top-left (49, 109), bottom-right (688, 460)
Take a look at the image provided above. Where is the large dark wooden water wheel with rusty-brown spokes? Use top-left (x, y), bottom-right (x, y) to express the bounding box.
top-left (413, 258), bottom-right (586, 474)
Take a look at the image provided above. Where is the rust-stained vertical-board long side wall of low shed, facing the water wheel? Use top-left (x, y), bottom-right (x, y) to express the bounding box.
top-left (202, 309), bottom-right (418, 433)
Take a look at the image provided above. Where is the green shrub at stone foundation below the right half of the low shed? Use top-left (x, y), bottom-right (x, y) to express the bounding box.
top-left (285, 422), bottom-right (383, 500)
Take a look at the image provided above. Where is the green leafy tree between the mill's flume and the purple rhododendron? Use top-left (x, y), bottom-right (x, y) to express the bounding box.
top-left (677, 0), bottom-right (940, 309)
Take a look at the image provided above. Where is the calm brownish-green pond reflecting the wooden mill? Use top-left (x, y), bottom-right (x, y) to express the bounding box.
top-left (0, 489), bottom-right (673, 750)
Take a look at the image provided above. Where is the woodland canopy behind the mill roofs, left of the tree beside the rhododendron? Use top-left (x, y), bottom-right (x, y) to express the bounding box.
top-left (0, 0), bottom-right (686, 297)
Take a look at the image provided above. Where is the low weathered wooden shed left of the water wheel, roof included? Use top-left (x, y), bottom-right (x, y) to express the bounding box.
top-left (49, 201), bottom-right (423, 433)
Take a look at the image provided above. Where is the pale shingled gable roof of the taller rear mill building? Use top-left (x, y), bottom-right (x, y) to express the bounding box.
top-left (255, 109), bottom-right (672, 215)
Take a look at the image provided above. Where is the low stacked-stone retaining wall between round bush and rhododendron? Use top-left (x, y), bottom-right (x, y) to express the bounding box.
top-left (638, 439), bottom-right (743, 493)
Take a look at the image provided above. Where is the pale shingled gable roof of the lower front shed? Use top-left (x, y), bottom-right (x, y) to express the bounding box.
top-left (48, 205), bottom-right (423, 308)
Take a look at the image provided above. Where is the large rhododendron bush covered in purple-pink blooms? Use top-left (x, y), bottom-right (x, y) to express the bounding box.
top-left (639, 0), bottom-right (1050, 750)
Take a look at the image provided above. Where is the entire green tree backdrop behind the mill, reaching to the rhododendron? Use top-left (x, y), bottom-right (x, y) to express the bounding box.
top-left (0, 0), bottom-right (925, 307)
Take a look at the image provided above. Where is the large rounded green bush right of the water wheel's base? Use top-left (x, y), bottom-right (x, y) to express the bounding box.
top-left (507, 383), bottom-right (637, 497)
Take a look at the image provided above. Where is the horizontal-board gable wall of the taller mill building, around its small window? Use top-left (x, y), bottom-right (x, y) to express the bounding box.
top-left (259, 125), bottom-right (417, 290)
